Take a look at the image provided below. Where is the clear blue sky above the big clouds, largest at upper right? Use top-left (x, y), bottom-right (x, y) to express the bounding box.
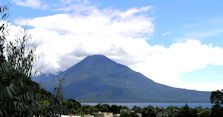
top-left (10, 0), bottom-right (223, 46)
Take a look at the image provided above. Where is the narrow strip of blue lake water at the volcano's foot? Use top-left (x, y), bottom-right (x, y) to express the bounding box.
top-left (82, 103), bottom-right (212, 109)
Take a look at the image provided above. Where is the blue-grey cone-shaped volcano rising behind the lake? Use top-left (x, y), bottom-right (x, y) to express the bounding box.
top-left (36, 55), bottom-right (209, 103)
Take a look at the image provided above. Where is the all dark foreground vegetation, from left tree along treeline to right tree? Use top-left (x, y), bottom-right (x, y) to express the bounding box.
top-left (0, 2), bottom-right (223, 117)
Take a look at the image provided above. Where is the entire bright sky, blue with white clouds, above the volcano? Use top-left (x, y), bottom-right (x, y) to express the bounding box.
top-left (3, 0), bottom-right (223, 91)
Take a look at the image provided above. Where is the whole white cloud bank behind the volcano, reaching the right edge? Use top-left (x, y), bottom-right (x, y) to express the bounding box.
top-left (12, 7), bottom-right (223, 90)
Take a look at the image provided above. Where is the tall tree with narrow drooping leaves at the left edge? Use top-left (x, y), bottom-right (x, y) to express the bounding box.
top-left (0, 5), bottom-right (44, 117)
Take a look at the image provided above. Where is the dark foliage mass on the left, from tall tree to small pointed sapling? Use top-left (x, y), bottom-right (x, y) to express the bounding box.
top-left (0, 3), bottom-right (72, 117)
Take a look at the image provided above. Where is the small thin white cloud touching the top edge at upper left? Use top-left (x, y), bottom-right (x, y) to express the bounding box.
top-left (12, 0), bottom-right (47, 9)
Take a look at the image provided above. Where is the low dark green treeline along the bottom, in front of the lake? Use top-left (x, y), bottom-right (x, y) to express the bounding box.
top-left (67, 104), bottom-right (223, 117)
